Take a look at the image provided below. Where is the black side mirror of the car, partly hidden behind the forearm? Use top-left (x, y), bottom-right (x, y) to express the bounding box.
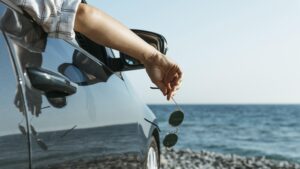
top-left (108, 29), bottom-right (168, 71)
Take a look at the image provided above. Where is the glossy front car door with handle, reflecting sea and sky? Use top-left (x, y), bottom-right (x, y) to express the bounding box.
top-left (3, 5), bottom-right (143, 168)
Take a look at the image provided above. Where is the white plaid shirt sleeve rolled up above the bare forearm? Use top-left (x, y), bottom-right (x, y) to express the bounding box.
top-left (11, 0), bottom-right (81, 40)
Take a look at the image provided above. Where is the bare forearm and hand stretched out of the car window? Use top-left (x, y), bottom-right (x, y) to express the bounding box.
top-left (74, 4), bottom-right (182, 100)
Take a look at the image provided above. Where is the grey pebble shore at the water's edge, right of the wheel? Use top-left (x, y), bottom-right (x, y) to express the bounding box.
top-left (160, 149), bottom-right (300, 169)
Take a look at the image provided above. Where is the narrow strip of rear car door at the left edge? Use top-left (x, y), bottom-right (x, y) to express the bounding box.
top-left (0, 19), bottom-right (30, 169)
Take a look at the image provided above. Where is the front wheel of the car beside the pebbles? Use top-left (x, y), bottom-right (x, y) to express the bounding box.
top-left (143, 136), bottom-right (160, 169)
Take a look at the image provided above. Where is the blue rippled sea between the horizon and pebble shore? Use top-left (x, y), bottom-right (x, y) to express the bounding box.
top-left (150, 105), bottom-right (300, 163)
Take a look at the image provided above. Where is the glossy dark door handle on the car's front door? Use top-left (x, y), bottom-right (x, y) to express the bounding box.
top-left (27, 67), bottom-right (77, 97)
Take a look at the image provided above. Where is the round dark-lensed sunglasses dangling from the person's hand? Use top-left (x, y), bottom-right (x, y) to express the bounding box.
top-left (150, 87), bottom-right (184, 148)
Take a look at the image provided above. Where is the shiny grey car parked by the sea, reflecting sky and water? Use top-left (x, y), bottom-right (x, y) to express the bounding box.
top-left (0, 0), bottom-right (167, 169)
